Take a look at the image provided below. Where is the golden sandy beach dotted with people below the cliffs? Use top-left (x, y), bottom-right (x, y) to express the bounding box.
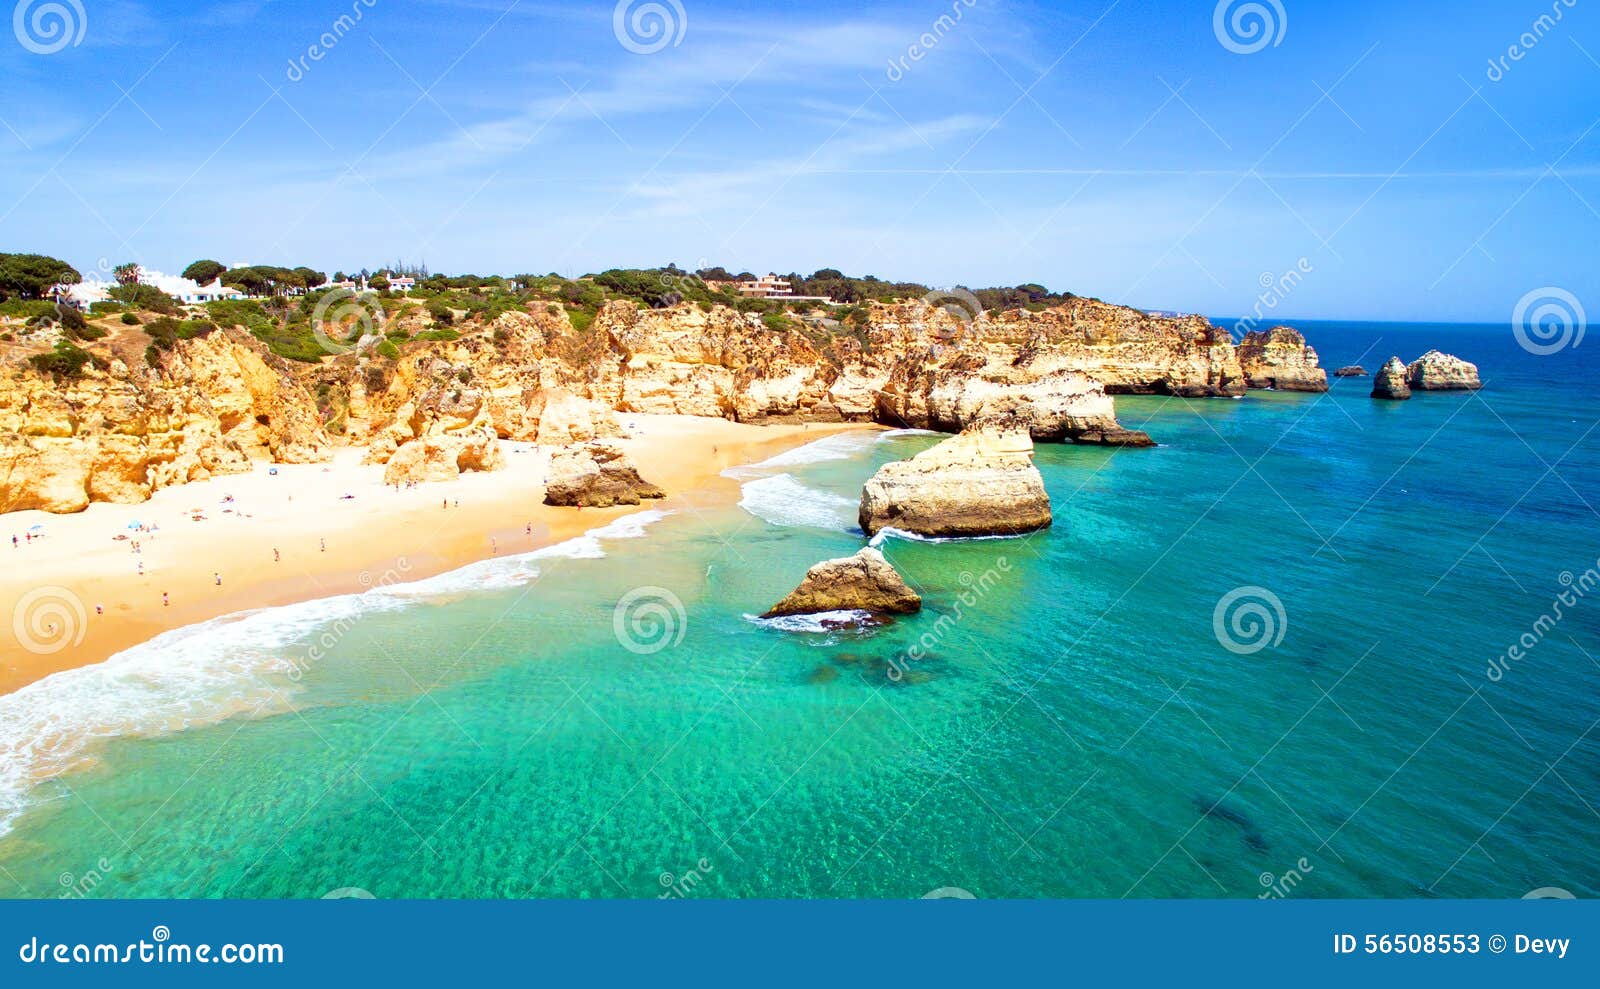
top-left (0, 413), bottom-right (877, 693)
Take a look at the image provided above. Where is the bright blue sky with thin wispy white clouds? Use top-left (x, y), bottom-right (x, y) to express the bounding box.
top-left (0, 0), bottom-right (1600, 322)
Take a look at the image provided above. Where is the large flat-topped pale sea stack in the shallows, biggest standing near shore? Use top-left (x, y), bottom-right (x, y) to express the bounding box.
top-left (859, 421), bottom-right (1051, 536)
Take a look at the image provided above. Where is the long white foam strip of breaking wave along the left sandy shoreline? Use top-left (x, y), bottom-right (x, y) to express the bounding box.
top-left (0, 511), bottom-right (667, 835)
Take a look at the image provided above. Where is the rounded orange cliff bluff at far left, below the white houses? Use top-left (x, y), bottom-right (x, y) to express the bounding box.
top-left (0, 331), bottom-right (333, 512)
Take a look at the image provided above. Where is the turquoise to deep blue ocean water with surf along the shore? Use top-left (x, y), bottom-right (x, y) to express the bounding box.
top-left (0, 323), bottom-right (1600, 898)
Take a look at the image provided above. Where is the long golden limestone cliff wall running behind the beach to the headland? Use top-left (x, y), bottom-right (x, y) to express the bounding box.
top-left (0, 291), bottom-right (1315, 511)
